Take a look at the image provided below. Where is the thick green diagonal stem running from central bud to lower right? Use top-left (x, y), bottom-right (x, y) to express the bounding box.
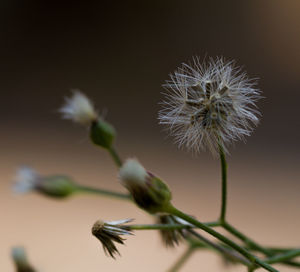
top-left (164, 204), bottom-right (278, 272)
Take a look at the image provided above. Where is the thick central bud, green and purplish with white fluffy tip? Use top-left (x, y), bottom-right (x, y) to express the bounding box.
top-left (120, 159), bottom-right (172, 213)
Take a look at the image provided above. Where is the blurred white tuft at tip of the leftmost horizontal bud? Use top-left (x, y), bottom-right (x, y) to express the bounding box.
top-left (14, 166), bottom-right (39, 194)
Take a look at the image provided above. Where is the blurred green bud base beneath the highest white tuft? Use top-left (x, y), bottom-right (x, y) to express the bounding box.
top-left (90, 118), bottom-right (116, 149)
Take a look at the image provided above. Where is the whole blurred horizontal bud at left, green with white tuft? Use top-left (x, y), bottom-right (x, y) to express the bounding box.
top-left (14, 167), bottom-right (77, 198)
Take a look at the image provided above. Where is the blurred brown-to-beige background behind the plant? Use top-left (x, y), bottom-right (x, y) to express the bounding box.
top-left (0, 0), bottom-right (300, 272)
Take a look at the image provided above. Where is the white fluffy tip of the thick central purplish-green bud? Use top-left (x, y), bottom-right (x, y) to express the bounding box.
top-left (119, 159), bottom-right (148, 187)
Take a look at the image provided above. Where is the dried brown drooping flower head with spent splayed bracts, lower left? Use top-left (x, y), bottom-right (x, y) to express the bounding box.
top-left (92, 219), bottom-right (132, 258)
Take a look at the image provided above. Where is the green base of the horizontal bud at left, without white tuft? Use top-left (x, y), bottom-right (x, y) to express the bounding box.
top-left (36, 176), bottom-right (77, 198)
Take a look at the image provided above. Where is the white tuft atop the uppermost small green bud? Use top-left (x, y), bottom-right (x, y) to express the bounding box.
top-left (59, 90), bottom-right (98, 125)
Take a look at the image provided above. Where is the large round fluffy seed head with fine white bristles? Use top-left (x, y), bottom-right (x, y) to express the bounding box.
top-left (159, 58), bottom-right (260, 154)
